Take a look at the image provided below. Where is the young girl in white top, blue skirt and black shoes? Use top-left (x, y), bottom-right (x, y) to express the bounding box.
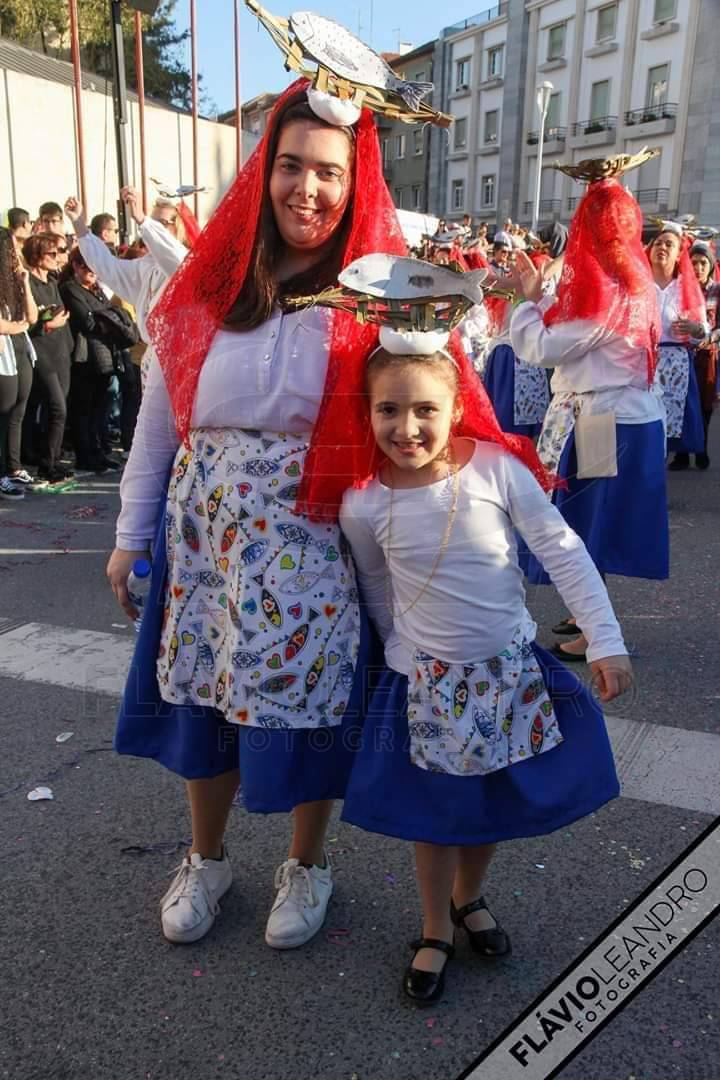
top-left (340, 317), bottom-right (630, 1004)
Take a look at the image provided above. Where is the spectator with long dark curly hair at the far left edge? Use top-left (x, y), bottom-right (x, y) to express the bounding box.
top-left (0, 229), bottom-right (38, 499)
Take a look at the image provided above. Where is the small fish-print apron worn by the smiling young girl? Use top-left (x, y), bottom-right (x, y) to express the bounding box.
top-left (408, 616), bottom-right (562, 777)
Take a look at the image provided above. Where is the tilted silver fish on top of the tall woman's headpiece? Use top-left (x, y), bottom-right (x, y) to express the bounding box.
top-left (289, 11), bottom-right (434, 112)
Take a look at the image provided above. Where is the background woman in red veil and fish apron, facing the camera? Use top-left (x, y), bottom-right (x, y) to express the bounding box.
top-left (648, 221), bottom-right (709, 470)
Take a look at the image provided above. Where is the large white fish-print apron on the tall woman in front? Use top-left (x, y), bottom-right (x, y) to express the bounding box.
top-left (158, 428), bottom-right (359, 729)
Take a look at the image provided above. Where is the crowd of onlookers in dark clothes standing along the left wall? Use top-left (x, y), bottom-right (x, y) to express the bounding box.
top-left (0, 188), bottom-right (187, 499)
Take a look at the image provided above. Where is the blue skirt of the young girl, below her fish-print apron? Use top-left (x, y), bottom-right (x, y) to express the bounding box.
top-left (342, 645), bottom-right (620, 846)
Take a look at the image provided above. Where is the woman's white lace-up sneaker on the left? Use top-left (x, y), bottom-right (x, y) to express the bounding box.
top-left (160, 848), bottom-right (232, 945)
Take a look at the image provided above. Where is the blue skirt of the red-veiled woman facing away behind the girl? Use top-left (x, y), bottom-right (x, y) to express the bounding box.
top-left (518, 420), bottom-right (670, 585)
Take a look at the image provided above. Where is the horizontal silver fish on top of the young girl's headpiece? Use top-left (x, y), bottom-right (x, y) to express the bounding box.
top-left (338, 253), bottom-right (488, 303)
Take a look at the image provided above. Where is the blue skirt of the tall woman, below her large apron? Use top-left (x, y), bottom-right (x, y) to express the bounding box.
top-left (114, 515), bottom-right (382, 813)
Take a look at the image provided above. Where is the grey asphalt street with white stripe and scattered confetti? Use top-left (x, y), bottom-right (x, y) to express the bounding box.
top-left (0, 432), bottom-right (720, 1080)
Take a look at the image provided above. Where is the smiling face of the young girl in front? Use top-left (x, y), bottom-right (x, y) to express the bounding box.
top-left (368, 360), bottom-right (460, 484)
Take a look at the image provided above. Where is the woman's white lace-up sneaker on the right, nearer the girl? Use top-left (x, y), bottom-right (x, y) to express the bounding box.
top-left (264, 855), bottom-right (332, 948)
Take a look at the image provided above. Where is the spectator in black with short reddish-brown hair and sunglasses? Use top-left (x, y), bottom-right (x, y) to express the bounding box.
top-left (23, 232), bottom-right (72, 484)
